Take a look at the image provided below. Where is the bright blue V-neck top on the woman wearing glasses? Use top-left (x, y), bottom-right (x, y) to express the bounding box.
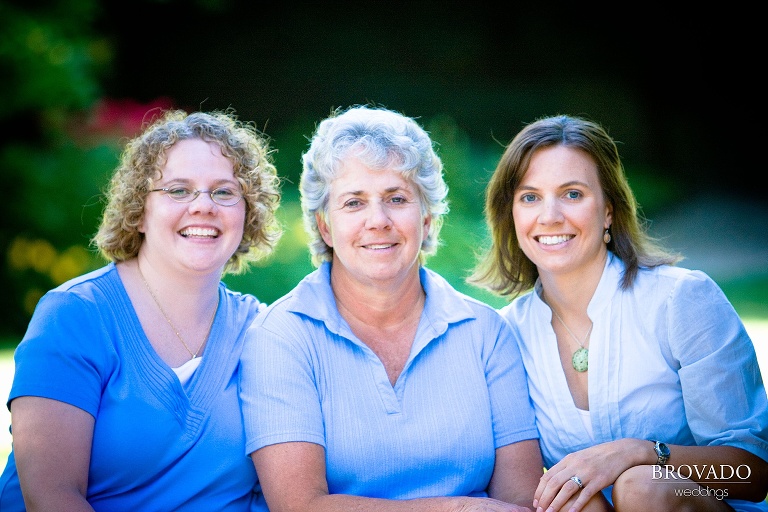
top-left (0, 263), bottom-right (260, 512)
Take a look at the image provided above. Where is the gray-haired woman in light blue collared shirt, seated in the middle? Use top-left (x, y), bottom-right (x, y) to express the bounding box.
top-left (241, 106), bottom-right (543, 512)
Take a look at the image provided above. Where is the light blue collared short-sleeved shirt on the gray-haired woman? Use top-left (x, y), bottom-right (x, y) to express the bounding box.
top-left (241, 263), bottom-right (538, 499)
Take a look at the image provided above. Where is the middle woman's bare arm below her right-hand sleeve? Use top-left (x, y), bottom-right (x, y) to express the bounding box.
top-left (488, 439), bottom-right (544, 507)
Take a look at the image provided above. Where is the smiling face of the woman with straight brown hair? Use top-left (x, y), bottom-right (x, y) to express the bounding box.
top-left (512, 145), bottom-right (611, 278)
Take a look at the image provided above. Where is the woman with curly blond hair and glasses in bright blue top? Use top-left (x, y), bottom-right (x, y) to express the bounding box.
top-left (0, 106), bottom-right (280, 512)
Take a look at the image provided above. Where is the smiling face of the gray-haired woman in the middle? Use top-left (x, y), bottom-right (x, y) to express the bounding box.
top-left (317, 157), bottom-right (430, 285)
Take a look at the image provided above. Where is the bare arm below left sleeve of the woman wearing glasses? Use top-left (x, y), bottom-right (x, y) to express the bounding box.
top-left (11, 396), bottom-right (94, 512)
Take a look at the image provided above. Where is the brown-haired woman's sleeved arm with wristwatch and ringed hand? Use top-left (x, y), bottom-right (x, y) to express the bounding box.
top-left (536, 271), bottom-right (768, 510)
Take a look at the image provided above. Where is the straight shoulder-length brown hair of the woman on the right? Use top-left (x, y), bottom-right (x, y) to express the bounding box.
top-left (467, 115), bottom-right (681, 297)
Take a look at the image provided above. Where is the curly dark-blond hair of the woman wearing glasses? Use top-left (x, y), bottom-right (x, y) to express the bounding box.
top-left (91, 109), bottom-right (282, 274)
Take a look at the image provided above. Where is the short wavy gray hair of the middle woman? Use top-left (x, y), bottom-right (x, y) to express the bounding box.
top-left (299, 105), bottom-right (448, 266)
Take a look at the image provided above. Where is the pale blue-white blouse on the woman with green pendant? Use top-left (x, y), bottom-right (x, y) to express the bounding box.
top-left (501, 252), bottom-right (768, 510)
